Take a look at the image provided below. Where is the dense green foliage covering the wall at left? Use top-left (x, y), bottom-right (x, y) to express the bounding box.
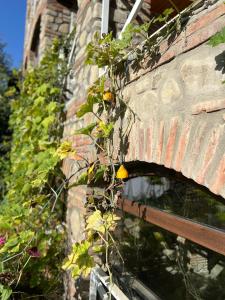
top-left (0, 40), bottom-right (72, 299)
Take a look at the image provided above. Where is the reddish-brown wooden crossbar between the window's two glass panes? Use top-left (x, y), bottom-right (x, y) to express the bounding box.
top-left (117, 198), bottom-right (225, 255)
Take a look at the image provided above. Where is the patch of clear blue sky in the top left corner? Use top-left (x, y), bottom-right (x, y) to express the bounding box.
top-left (0, 0), bottom-right (26, 67)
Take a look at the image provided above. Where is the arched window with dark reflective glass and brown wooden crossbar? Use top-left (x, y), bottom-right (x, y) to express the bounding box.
top-left (112, 163), bottom-right (225, 300)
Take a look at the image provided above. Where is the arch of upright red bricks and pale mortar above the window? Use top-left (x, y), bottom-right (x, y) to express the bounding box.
top-left (125, 117), bottom-right (225, 197)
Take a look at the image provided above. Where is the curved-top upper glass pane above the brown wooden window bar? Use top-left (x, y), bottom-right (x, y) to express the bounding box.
top-left (122, 176), bottom-right (225, 230)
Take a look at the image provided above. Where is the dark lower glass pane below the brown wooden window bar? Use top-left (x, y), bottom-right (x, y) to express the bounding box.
top-left (112, 214), bottom-right (225, 300)
